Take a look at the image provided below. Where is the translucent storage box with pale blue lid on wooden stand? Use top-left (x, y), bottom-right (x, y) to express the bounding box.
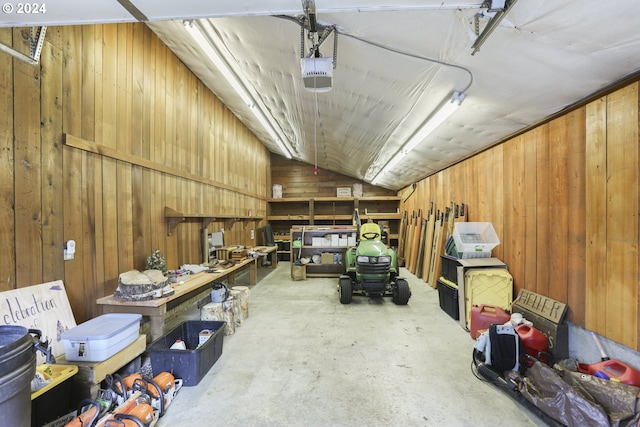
top-left (61, 313), bottom-right (142, 362)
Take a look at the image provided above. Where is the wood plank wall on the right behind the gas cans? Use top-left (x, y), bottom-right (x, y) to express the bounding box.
top-left (402, 82), bottom-right (640, 350)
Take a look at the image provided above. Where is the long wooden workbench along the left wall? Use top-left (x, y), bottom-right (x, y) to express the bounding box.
top-left (96, 258), bottom-right (258, 342)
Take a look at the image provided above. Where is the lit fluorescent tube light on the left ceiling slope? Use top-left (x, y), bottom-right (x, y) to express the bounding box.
top-left (184, 21), bottom-right (292, 159)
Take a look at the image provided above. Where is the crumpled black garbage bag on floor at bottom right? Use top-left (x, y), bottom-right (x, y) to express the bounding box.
top-left (520, 362), bottom-right (640, 427)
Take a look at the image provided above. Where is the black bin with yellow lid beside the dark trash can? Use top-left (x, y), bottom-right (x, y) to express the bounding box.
top-left (31, 363), bottom-right (78, 427)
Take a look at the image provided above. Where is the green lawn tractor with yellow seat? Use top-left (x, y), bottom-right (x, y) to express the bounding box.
top-left (338, 221), bottom-right (411, 305)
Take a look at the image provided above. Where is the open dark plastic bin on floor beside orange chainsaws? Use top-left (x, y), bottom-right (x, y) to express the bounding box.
top-left (147, 320), bottom-right (227, 386)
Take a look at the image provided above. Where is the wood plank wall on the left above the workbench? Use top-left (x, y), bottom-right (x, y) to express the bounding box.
top-left (0, 23), bottom-right (271, 322)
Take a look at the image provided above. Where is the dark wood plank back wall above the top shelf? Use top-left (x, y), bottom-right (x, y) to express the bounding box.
top-left (269, 153), bottom-right (396, 198)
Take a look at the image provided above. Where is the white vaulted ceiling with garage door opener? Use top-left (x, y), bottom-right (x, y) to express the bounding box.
top-left (5, 0), bottom-right (640, 189)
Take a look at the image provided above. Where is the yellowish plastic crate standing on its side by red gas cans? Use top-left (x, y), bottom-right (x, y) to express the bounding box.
top-left (464, 268), bottom-right (513, 329)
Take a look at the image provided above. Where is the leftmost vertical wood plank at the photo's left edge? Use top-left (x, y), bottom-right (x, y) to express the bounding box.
top-left (0, 28), bottom-right (16, 291)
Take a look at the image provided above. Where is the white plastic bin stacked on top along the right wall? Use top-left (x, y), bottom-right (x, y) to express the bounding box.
top-left (453, 222), bottom-right (500, 259)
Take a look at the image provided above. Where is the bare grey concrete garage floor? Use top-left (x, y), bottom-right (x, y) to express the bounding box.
top-left (154, 262), bottom-right (547, 427)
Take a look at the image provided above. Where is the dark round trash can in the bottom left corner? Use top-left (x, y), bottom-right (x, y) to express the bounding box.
top-left (0, 325), bottom-right (36, 427)
